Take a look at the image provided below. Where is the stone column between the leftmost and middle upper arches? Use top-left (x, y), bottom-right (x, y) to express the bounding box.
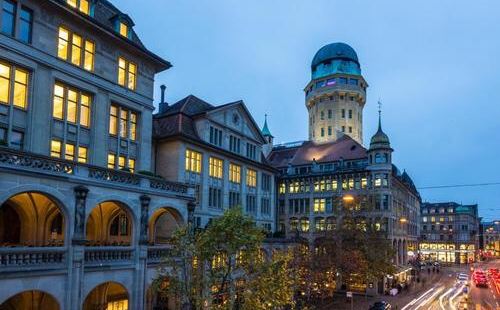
top-left (67, 185), bottom-right (89, 309)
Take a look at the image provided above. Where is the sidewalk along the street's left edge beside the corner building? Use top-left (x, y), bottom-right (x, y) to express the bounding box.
top-left (318, 268), bottom-right (455, 310)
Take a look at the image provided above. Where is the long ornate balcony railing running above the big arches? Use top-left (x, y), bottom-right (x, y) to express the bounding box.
top-left (0, 146), bottom-right (194, 197)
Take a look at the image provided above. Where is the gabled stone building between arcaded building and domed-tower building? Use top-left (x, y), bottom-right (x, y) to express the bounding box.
top-left (154, 95), bottom-right (276, 232)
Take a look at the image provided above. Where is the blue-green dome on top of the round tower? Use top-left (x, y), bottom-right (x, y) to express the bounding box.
top-left (311, 42), bottom-right (361, 79)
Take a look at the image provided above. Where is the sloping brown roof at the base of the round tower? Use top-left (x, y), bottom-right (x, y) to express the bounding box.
top-left (268, 135), bottom-right (366, 168)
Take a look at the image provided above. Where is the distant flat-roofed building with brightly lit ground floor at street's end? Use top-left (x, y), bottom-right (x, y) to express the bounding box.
top-left (419, 202), bottom-right (480, 264)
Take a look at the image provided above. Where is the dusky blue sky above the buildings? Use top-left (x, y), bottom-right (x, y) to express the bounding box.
top-left (112, 0), bottom-right (500, 220)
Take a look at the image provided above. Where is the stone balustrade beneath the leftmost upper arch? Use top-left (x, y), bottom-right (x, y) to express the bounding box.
top-left (0, 247), bottom-right (66, 272)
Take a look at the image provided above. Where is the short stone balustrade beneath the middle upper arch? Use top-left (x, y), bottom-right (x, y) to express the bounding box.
top-left (85, 246), bottom-right (134, 266)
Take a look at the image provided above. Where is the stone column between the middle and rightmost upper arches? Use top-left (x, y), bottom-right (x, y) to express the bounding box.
top-left (136, 195), bottom-right (151, 309)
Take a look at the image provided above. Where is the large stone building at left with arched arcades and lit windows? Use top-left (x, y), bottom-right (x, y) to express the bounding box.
top-left (0, 0), bottom-right (194, 309)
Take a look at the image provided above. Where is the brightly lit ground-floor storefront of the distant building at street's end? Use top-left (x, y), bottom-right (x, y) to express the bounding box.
top-left (419, 242), bottom-right (476, 264)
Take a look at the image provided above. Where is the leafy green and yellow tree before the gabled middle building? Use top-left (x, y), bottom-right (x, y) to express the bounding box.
top-left (155, 208), bottom-right (294, 309)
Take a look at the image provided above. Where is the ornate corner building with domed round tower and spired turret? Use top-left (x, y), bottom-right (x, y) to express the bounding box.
top-left (264, 43), bottom-right (421, 292)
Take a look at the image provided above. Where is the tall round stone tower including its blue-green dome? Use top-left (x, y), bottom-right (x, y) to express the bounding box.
top-left (304, 43), bottom-right (368, 144)
